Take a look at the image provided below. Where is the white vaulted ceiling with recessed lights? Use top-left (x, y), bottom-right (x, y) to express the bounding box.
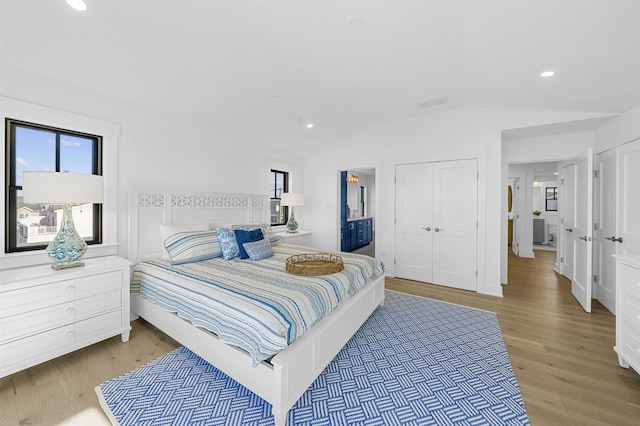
top-left (0, 0), bottom-right (640, 146)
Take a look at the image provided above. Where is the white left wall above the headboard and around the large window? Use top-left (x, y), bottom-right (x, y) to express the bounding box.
top-left (0, 65), bottom-right (306, 260)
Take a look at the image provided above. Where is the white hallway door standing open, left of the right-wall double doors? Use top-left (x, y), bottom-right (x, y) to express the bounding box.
top-left (571, 148), bottom-right (593, 312)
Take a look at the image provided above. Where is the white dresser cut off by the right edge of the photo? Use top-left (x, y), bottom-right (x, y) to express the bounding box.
top-left (614, 255), bottom-right (640, 373)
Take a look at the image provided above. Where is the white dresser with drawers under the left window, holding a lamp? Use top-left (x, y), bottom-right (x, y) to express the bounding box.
top-left (0, 256), bottom-right (131, 377)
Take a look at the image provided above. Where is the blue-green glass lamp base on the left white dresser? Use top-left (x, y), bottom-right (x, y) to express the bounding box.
top-left (46, 204), bottom-right (87, 271)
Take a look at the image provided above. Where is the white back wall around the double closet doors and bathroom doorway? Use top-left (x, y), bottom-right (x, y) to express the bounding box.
top-left (305, 109), bottom-right (598, 295)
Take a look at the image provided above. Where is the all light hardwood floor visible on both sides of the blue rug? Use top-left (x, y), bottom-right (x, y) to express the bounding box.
top-left (0, 251), bottom-right (640, 426)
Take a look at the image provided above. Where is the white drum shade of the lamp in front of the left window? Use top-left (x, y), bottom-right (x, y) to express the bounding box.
top-left (22, 172), bottom-right (104, 204)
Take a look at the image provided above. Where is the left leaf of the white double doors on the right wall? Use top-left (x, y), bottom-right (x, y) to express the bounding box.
top-left (593, 149), bottom-right (618, 315)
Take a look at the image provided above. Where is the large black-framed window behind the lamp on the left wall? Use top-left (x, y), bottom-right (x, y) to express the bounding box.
top-left (5, 119), bottom-right (102, 253)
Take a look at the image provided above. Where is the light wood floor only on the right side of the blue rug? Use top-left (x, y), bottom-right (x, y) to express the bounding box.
top-left (386, 250), bottom-right (640, 426)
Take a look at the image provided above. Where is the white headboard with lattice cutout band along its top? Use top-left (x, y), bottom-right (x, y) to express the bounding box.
top-left (127, 189), bottom-right (269, 262)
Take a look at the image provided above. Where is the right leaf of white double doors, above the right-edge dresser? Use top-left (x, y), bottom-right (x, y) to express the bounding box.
top-left (616, 139), bottom-right (640, 255)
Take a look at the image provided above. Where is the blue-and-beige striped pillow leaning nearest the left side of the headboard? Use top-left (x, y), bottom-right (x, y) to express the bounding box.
top-left (164, 231), bottom-right (222, 265)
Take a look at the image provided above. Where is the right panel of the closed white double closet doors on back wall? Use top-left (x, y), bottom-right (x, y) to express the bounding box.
top-left (432, 159), bottom-right (478, 291)
